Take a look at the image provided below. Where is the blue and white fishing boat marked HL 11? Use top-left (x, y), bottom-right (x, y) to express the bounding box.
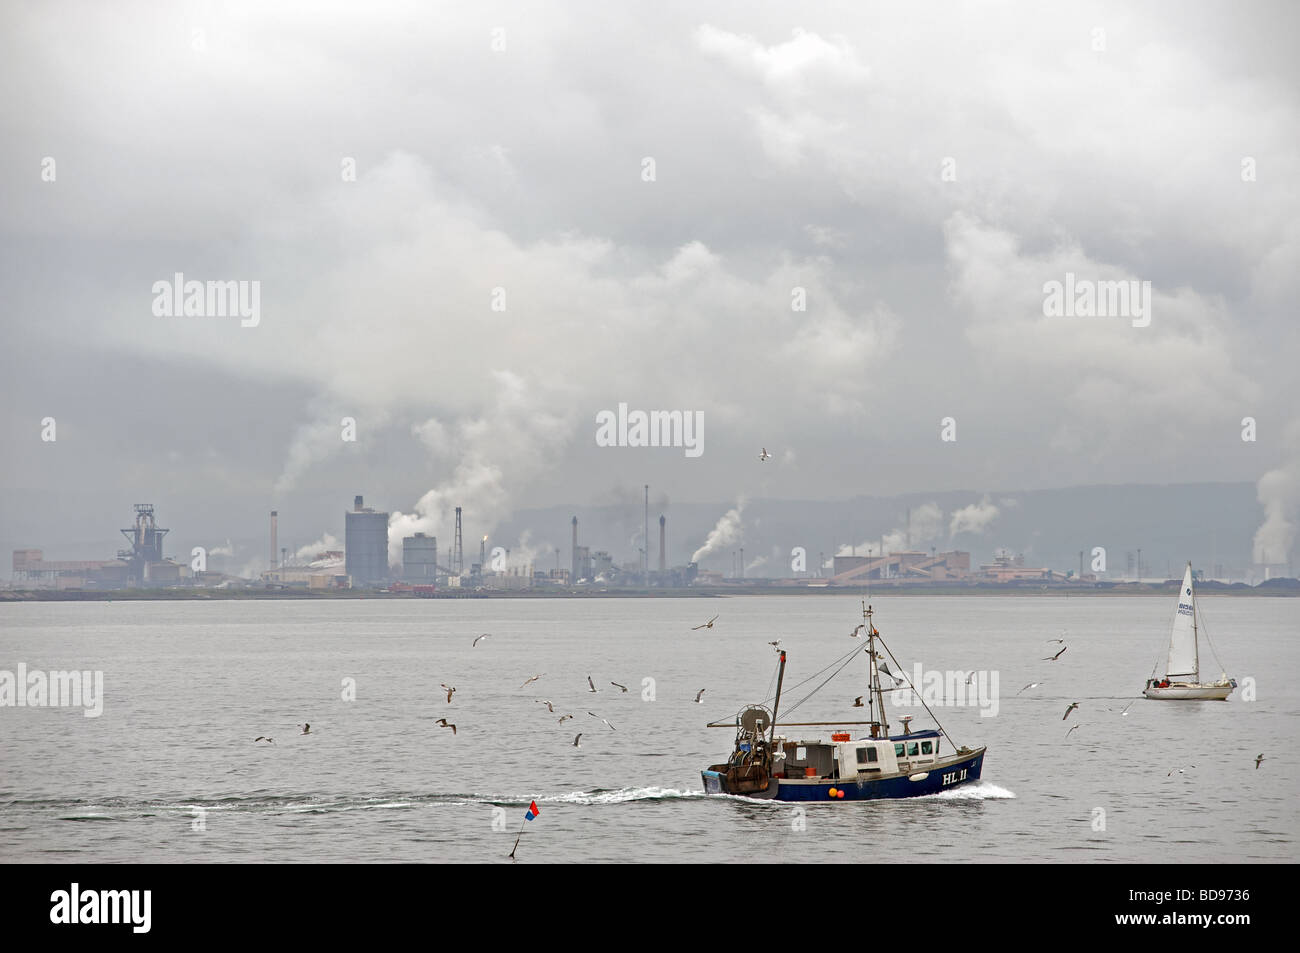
top-left (701, 605), bottom-right (987, 801)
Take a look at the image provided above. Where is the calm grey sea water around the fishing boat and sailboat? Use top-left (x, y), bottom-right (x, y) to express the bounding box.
top-left (0, 595), bottom-right (1300, 862)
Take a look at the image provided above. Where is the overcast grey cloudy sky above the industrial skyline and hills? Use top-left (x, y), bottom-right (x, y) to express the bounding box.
top-left (0, 3), bottom-right (1300, 558)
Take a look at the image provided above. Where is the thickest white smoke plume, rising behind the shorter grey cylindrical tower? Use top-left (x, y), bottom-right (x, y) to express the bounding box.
top-left (389, 371), bottom-right (572, 563)
